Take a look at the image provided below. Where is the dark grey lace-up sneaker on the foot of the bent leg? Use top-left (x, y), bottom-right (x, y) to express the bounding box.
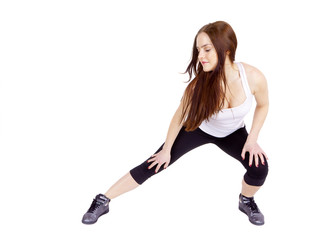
top-left (239, 194), bottom-right (265, 225)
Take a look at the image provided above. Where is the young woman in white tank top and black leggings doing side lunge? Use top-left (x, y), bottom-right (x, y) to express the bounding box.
top-left (82, 21), bottom-right (268, 225)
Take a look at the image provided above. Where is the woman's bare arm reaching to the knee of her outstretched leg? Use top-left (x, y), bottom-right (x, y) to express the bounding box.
top-left (148, 101), bottom-right (183, 172)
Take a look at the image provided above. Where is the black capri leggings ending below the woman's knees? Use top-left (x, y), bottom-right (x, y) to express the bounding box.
top-left (130, 127), bottom-right (268, 186)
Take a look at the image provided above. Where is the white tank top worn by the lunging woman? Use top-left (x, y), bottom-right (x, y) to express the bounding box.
top-left (199, 62), bottom-right (253, 138)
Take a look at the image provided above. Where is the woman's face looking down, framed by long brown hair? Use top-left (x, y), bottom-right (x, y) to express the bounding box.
top-left (196, 32), bottom-right (218, 72)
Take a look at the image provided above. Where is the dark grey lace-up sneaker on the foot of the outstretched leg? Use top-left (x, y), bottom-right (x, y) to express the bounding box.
top-left (82, 194), bottom-right (110, 224)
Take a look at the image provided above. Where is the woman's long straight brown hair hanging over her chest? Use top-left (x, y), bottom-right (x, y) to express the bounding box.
top-left (181, 21), bottom-right (237, 131)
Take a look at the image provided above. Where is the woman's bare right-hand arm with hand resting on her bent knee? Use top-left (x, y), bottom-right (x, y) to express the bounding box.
top-left (242, 65), bottom-right (269, 167)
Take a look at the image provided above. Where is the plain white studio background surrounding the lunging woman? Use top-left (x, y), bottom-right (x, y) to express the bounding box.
top-left (0, 0), bottom-right (336, 240)
